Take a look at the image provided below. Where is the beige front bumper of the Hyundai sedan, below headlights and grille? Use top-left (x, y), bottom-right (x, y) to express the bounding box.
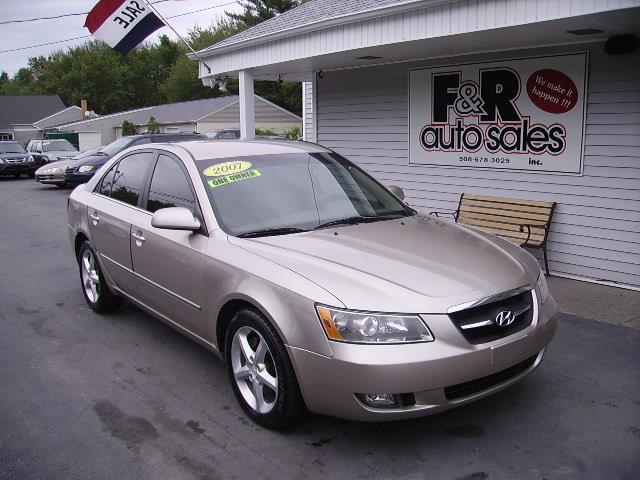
top-left (287, 288), bottom-right (557, 421)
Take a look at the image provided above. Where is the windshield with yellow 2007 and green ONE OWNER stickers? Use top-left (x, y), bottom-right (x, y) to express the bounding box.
top-left (198, 153), bottom-right (413, 236)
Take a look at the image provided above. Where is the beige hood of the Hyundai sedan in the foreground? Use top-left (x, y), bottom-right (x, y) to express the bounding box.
top-left (229, 215), bottom-right (540, 313)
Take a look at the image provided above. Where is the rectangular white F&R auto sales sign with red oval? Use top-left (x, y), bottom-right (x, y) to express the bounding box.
top-left (409, 53), bottom-right (587, 173)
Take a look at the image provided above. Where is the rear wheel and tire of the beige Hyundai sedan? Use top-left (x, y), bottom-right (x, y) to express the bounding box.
top-left (78, 240), bottom-right (122, 313)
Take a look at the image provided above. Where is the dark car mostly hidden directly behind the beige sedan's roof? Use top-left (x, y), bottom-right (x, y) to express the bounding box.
top-left (64, 133), bottom-right (205, 186)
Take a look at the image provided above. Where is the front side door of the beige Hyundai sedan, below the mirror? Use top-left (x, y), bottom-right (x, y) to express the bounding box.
top-left (131, 152), bottom-right (208, 335)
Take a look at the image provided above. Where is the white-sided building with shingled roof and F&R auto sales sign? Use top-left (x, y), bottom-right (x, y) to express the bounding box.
top-left (192, 0), bottom-right (640, 288)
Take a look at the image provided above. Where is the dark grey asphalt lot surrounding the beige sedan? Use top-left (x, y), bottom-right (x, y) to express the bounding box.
top-left (0, 179), bottom-right (640, 480)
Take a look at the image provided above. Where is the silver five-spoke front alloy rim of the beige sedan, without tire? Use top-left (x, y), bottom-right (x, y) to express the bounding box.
top-left (231, 326), bottom-right (278, 414)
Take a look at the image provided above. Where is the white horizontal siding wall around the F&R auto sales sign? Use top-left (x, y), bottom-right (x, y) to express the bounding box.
top-left (316, 44), bottom-right (640, 287)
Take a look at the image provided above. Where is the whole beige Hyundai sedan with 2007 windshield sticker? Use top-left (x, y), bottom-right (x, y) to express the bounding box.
top-left (68, 141), bottom-right (556, 428)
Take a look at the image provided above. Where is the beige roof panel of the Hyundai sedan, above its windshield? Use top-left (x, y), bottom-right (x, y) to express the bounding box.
top-left (155, 139), bottom-right (331, 161)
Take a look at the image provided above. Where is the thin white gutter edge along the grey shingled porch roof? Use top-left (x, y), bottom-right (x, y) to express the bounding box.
top-left (192, 0), bottom-right (453, 60)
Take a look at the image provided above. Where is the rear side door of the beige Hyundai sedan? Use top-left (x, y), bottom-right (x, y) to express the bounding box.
top-left (87, 151), bottom-right (154, 297)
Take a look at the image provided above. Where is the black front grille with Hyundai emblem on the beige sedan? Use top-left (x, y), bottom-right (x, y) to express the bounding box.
top-left (449, 290), bottom-right (533, 345)
